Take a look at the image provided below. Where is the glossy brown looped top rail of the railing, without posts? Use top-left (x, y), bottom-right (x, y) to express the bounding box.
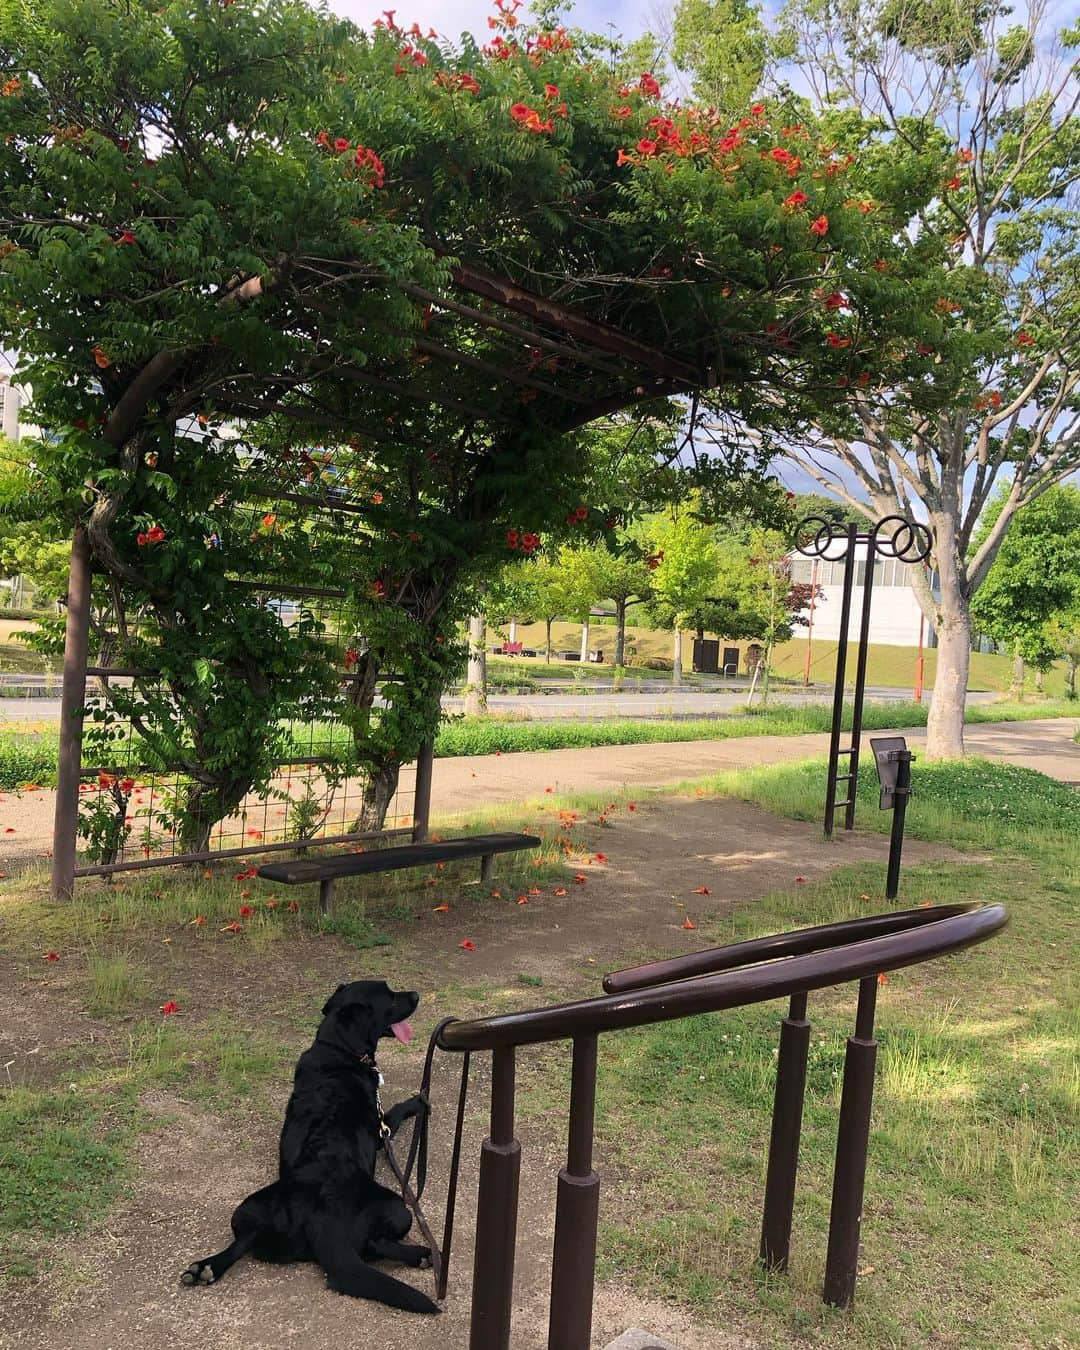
top-left (439, 905), bottom-right (1008, 1052)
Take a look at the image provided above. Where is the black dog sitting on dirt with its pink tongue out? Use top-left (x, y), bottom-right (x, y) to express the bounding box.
top-left (181, 980), bottom-right (440, 1312)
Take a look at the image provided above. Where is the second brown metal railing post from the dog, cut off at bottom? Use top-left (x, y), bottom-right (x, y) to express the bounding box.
top-left (548, 1034), bottom-right (599, 1350)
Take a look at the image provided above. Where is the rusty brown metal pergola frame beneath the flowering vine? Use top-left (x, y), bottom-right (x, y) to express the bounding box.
top-left (53, 244), bottom-right (745, 896)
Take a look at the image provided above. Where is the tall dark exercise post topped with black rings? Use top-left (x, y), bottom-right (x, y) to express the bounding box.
top-left (795, 516), bottom-right (934, 838)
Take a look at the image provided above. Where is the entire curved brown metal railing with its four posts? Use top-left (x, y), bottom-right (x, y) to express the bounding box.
top-left (439, 905), bottom-right (1008, 1350)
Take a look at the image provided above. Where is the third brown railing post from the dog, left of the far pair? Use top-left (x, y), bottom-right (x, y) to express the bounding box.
top-left (761, 994), bottom-right (810, 1270)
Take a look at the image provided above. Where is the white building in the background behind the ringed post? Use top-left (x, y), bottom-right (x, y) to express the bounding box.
top-left (791, 543), bottom-right (937, 647)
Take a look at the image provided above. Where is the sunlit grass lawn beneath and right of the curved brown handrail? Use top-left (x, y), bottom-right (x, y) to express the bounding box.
top-left (553, 761), bottom-right (1080, 1350)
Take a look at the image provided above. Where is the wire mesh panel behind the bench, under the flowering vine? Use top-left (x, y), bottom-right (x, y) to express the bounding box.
top-left (68, 582), bottom-right (416, 876)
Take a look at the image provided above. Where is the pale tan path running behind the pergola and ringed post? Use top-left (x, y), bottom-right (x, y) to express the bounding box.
top-left (0, 717), bottom-right (1080, 871)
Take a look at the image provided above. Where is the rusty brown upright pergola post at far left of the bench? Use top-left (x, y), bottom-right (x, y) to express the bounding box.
top-left (53, 525), bottom-right (90, 900)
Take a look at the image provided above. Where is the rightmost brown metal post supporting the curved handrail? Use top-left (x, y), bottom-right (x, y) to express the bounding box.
top-left (822, 975), bottom-right (878, 1308)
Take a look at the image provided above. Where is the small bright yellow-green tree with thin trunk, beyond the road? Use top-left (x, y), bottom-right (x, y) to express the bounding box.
top-left (644, 497), bottom-right (720, 684)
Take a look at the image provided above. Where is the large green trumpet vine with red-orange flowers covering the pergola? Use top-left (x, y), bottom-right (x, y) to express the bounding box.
top-left (0, 0), bottom-right (977, 838)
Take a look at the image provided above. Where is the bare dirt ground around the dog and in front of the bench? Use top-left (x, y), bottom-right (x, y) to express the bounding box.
top-left (0, 784), bottom-right (949, 1350)
